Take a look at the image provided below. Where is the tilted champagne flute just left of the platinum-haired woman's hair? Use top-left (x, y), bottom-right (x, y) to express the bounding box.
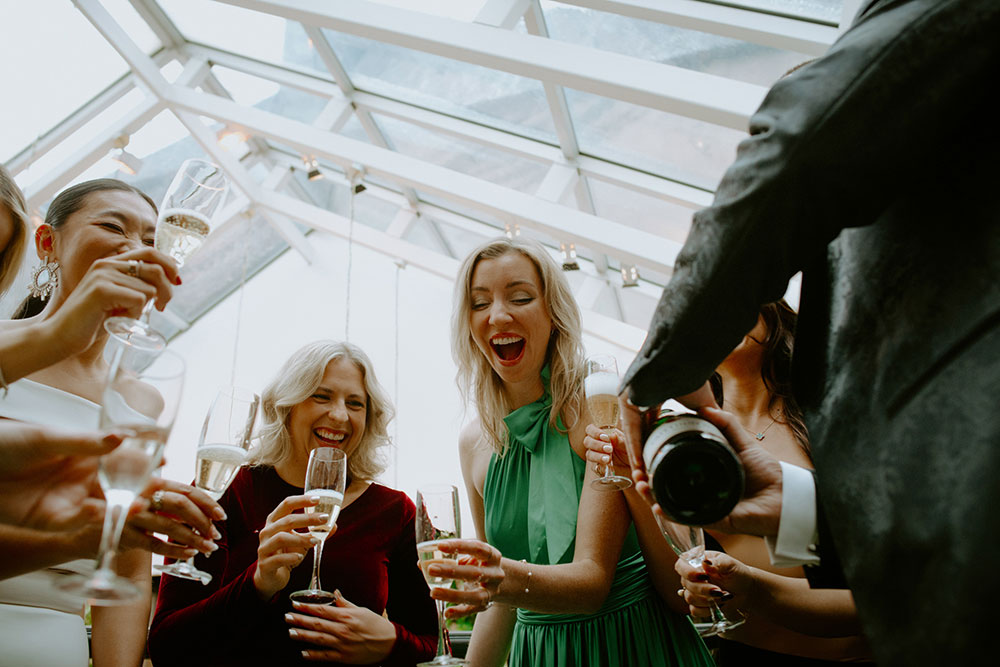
top-left (153, 386), bottom-right (260, 585)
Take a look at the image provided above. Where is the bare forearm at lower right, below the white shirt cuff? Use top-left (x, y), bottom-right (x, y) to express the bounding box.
top-left (753, 568), bottom-right (861, 637)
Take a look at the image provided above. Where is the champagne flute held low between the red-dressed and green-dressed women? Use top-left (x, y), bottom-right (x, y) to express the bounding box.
top-left (416, 484), bottom-right (466, 666)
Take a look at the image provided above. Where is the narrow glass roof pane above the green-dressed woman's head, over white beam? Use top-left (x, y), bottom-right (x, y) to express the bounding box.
top-left (372, 114), bottom-right (547, 193)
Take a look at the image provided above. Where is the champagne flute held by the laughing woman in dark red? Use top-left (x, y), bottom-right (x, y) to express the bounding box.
top-left (288, 447), bottom-right (347, 604)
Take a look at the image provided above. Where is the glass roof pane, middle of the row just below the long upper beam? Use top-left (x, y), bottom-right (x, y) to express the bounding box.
top-left (323, 30), bottom-right (557, 144)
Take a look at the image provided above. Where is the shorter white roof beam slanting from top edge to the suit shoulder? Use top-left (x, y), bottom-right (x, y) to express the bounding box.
top-left (559, 0), bottom-right (837, 56)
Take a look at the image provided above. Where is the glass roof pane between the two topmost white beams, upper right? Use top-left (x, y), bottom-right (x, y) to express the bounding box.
top-left (544, 2), bottom-right (811, 87)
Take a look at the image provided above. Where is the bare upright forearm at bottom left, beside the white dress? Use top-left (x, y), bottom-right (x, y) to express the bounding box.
top-left (91, 549), bottom-right (152, 667)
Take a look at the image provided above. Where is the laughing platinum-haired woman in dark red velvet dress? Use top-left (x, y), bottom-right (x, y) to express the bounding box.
top-left (149, 341), bottom-right (437, 667)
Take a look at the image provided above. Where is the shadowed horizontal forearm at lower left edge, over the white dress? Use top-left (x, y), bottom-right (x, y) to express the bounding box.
top-left (0, 526), bottom-right (95, 579)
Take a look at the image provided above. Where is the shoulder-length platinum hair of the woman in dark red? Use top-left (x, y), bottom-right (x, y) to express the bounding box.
top-left (249, 340), bottom-right (395, 480)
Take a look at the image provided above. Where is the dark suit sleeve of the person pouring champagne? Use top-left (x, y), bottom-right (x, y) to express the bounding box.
top-left (623, 0), bottom-right (1000, 405)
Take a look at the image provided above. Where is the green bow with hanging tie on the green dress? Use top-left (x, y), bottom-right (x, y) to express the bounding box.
top-left (504, 366), bottom-right (583, 565)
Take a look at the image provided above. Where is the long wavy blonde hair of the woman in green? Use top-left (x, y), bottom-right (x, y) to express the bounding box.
top-left (451, 237), bottom-right (584, 455)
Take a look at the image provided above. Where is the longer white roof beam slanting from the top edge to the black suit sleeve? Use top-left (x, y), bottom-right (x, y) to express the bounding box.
top-left (209, 0), bottom-right (767, 131)
